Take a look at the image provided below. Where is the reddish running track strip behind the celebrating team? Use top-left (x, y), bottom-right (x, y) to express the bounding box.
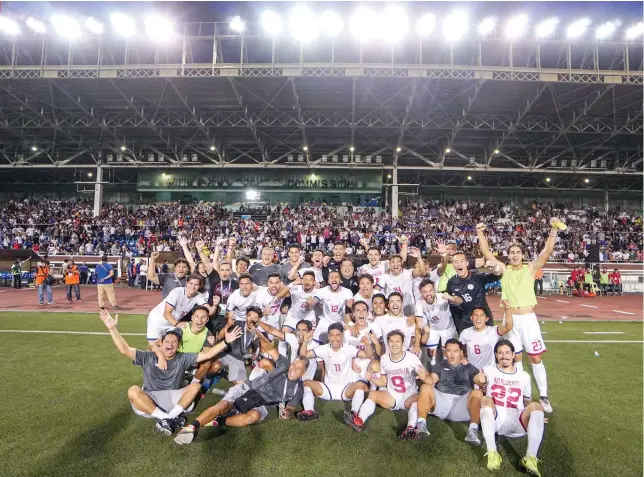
top-left (0, 285), bottom-right (644, 321)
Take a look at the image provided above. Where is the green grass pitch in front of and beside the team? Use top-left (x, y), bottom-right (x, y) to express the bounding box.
top-left (0, 313), bottom-right (643, 477)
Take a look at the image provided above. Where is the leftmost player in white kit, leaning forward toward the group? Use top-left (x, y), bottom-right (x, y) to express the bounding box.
top-left (146, 275), bottom-right (215, 344)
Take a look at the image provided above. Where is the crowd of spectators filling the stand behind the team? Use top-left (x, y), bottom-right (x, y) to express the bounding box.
top-left (0, 199), bottom-right (642, 262)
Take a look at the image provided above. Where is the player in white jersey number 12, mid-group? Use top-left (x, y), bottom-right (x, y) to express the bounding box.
top-left (307, 270), bottom-right (353, 343)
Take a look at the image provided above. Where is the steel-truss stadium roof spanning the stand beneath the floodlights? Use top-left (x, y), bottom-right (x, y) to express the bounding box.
top-left (0, 18), bottom-right (644, 189)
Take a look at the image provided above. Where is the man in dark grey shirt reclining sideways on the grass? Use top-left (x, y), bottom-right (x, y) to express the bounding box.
top-left (174, 326), bottom-right (309, 444)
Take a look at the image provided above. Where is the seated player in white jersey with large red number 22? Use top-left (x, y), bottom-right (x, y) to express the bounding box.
top-left (481, 339), bottom-right (545, 477)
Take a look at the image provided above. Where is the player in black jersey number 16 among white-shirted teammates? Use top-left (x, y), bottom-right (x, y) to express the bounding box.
top-left (447, 252), bottom-right (500, 334)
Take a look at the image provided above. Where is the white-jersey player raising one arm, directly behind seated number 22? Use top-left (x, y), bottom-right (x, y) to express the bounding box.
top-left (459, 300), bottom-right (514, 369)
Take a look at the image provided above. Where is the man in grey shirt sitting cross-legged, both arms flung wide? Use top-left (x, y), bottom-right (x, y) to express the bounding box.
top-left (101, 310), bottom-right (241, 436)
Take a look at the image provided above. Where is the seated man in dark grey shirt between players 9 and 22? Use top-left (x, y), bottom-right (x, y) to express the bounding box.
top-left (416, 338), bottom-right (485, 446)
